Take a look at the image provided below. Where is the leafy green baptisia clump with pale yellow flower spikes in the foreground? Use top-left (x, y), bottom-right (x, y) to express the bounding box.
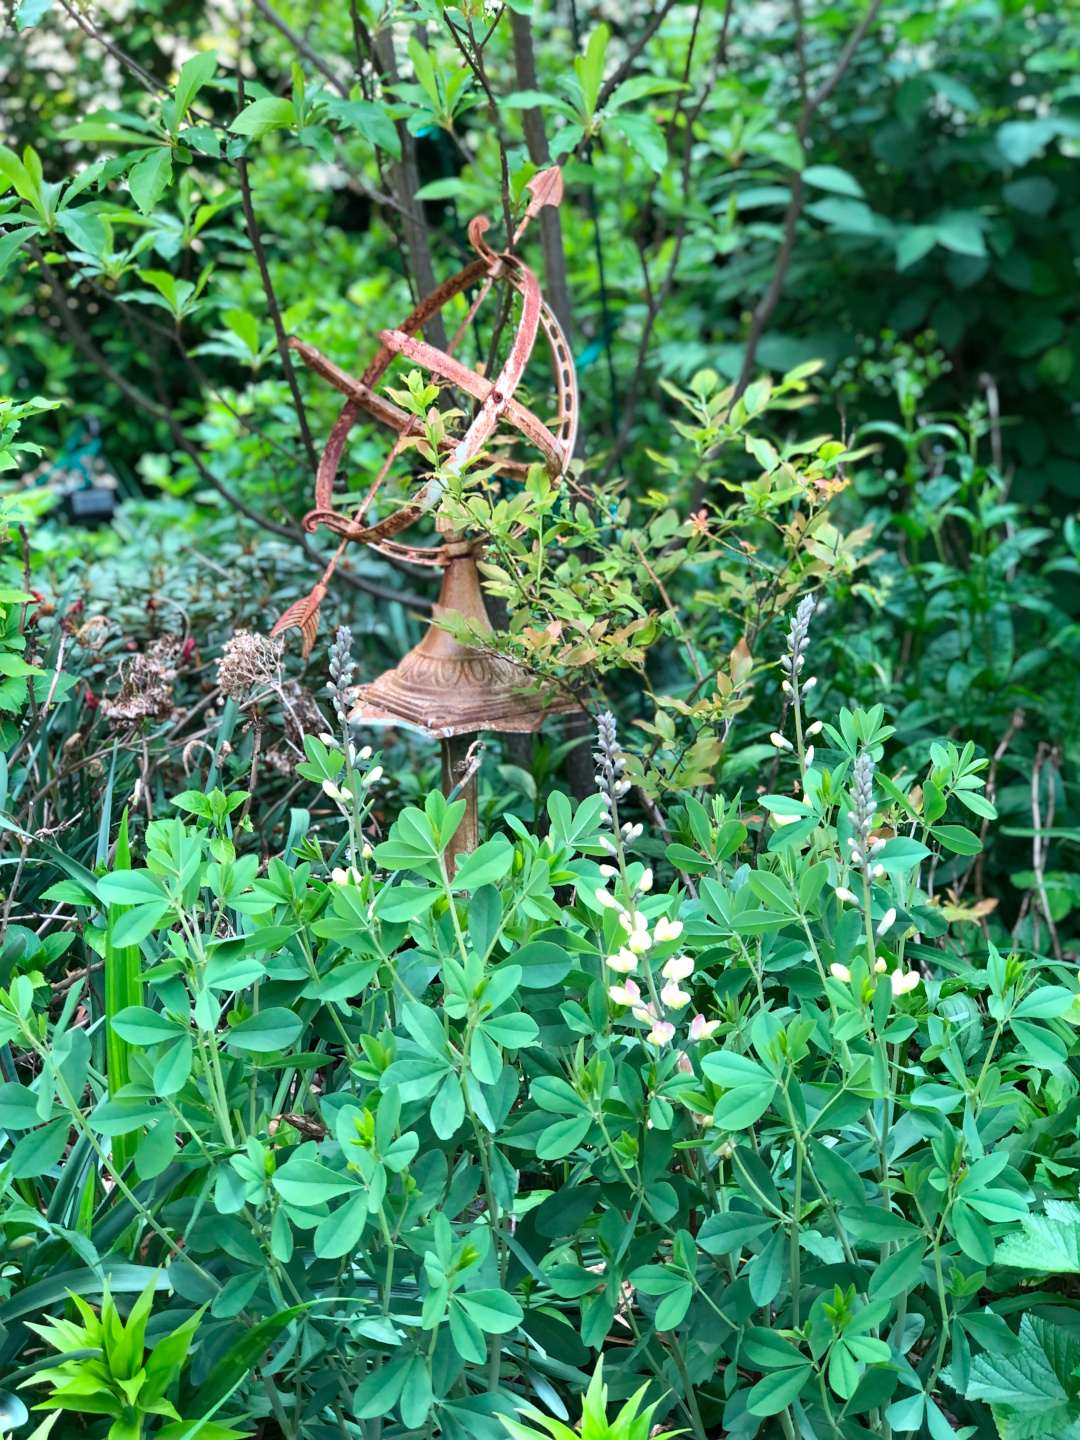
top-left (0, 603), bottom-right (1080, 1440)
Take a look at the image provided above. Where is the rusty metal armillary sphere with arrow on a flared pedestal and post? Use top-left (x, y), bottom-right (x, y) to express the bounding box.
top-left (271, 167), bottom-right (577, 860)
